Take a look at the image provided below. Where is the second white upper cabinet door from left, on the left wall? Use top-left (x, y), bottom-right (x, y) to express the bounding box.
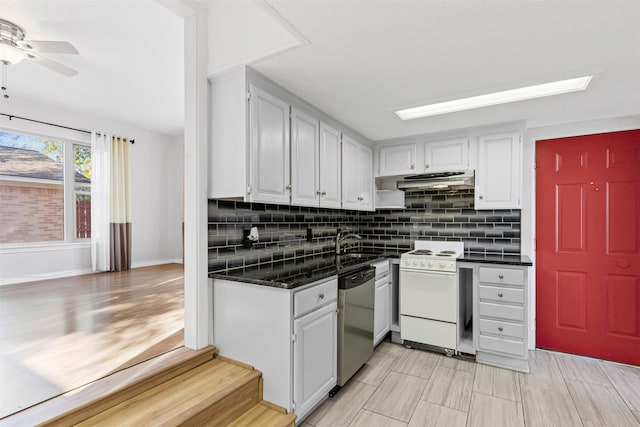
top-left (291, 108), bottom-right (320, 206)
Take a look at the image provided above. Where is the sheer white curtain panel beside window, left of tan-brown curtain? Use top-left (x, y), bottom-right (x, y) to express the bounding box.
top-left (91, 132), bottom-right (111, 271)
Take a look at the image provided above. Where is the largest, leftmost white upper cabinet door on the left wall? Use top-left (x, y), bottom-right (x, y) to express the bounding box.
top-left (250, 86), bottom-right (291, 204)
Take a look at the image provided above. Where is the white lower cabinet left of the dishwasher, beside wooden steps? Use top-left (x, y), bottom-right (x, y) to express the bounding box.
top-left (211, 276), bottom-right (338, 423)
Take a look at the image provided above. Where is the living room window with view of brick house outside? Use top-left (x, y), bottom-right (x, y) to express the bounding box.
top-left (0, 131), bottom-right (91, 244)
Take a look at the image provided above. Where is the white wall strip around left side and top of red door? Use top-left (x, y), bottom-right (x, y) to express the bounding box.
top-left (521, 114), bottom-right (640, 349)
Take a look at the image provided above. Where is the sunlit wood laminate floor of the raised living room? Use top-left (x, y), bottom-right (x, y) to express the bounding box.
top-left (0, 264), bottom-right (184, 418)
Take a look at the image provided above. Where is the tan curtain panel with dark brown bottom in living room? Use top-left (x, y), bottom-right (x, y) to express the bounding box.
top-left (109, 136), bottom-right (131, 271)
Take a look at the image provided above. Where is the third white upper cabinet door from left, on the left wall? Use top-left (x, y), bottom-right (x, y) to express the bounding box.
top-left (319, 123), bottom-right (342, 209)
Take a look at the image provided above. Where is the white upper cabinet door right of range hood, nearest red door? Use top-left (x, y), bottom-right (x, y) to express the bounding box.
top-left (475, 132), bottom-right (522, 209)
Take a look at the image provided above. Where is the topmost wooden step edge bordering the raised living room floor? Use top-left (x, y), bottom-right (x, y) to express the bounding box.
top-left (0, 346), bottom-right (218, 427)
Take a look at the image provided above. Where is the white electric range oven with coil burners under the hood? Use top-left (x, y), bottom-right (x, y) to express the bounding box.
top-left (400, 240), bottom-right (464, 354)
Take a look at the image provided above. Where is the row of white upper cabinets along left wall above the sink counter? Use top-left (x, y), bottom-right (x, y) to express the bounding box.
top-left (207, 67), bottom-right (373, 209)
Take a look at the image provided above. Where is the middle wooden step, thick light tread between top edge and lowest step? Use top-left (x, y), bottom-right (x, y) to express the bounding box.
top-left (78, 359), bottom-right (262, 426)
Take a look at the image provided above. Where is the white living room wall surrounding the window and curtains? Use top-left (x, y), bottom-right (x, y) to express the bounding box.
top-left (0, 97), bottom-right (183, 284)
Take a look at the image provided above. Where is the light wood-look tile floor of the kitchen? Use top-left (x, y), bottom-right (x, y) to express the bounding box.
top-left (302, 342), bottom-right (640, 427)
